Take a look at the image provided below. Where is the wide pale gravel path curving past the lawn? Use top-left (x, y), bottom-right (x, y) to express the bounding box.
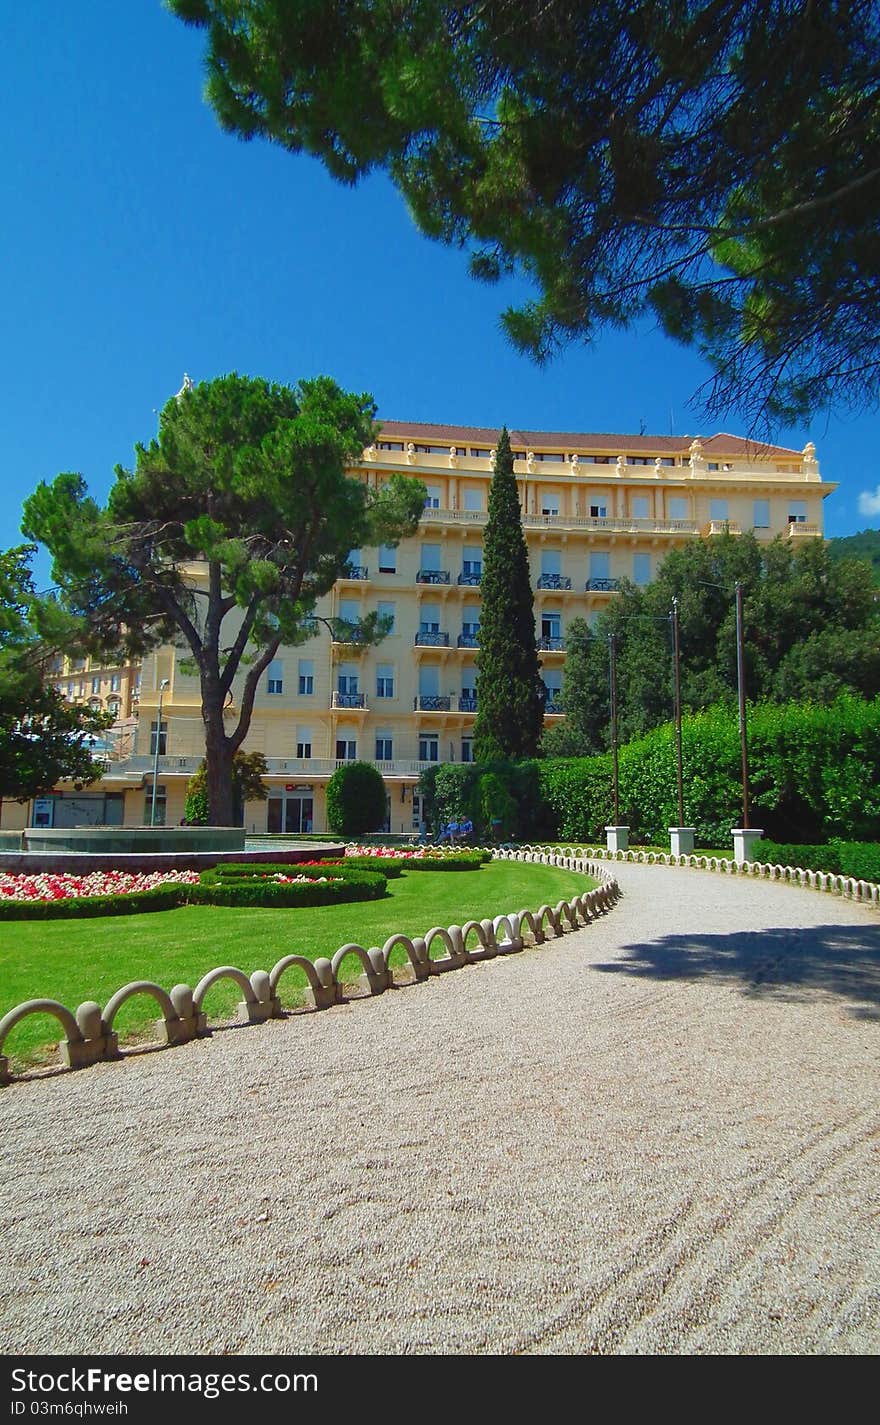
top-left (0, 865), bottom-right (880, 1354)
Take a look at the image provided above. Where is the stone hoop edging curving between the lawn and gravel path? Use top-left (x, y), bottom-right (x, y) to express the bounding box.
top-left (0, 848), bottom-right (622, 1084)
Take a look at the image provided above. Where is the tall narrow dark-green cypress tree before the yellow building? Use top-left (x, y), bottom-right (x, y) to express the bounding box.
top-left (474, 428), bottom-right (547, 762)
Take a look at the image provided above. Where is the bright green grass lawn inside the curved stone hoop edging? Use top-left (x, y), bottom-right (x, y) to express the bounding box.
top-left (0, 861), bottom-right (594, 1066)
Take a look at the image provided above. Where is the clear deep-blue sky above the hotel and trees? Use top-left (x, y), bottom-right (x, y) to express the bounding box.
top-left (6, 0), bottom-right (880, 581)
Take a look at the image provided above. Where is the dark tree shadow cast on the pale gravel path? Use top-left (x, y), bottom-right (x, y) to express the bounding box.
top-left (591, 925), bottom-right (880, 1022)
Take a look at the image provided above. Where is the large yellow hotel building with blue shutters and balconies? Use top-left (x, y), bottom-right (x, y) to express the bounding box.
top-left (4, 420), bottom-right (836, 832)
